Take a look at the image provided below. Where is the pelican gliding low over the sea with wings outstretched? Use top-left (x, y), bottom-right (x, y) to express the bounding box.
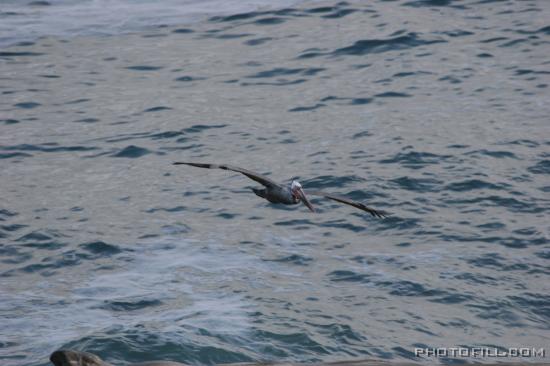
top-left (174, 161), bottom-right (388, 218)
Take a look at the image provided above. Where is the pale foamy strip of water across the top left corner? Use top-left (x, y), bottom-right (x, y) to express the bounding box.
top-left (0, 0), bottom-right (313, 47)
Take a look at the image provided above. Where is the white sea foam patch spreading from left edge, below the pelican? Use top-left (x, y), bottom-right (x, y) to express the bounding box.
top-left (0, 237), bottom-right (269, 365)
